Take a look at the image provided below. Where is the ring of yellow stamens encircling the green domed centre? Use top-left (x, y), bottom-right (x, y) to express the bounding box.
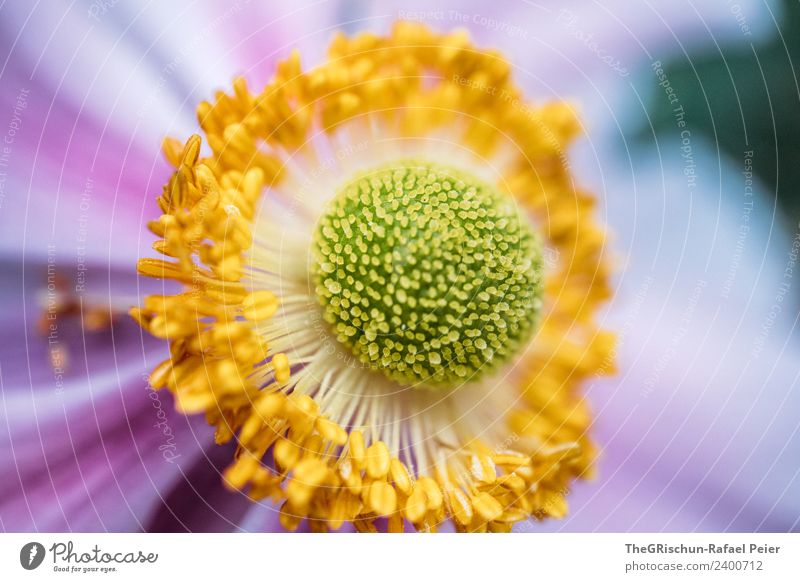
top-left (130, 23), bottom-right (614, 532)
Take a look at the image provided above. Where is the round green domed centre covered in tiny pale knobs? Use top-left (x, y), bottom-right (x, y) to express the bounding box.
top-left (312, 161), bottom-right (543, 387)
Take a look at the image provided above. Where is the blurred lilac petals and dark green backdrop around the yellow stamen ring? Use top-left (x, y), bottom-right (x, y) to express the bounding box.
top-left (0, 0), bottom-right (800, 532)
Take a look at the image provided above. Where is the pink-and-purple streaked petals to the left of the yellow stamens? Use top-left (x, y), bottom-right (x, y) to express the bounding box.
top-left (0, 2), bottom-right (342, 531)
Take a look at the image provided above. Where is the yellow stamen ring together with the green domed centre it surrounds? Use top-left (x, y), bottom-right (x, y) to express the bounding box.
top-left (131, 22), bottom-right (613, 531)
